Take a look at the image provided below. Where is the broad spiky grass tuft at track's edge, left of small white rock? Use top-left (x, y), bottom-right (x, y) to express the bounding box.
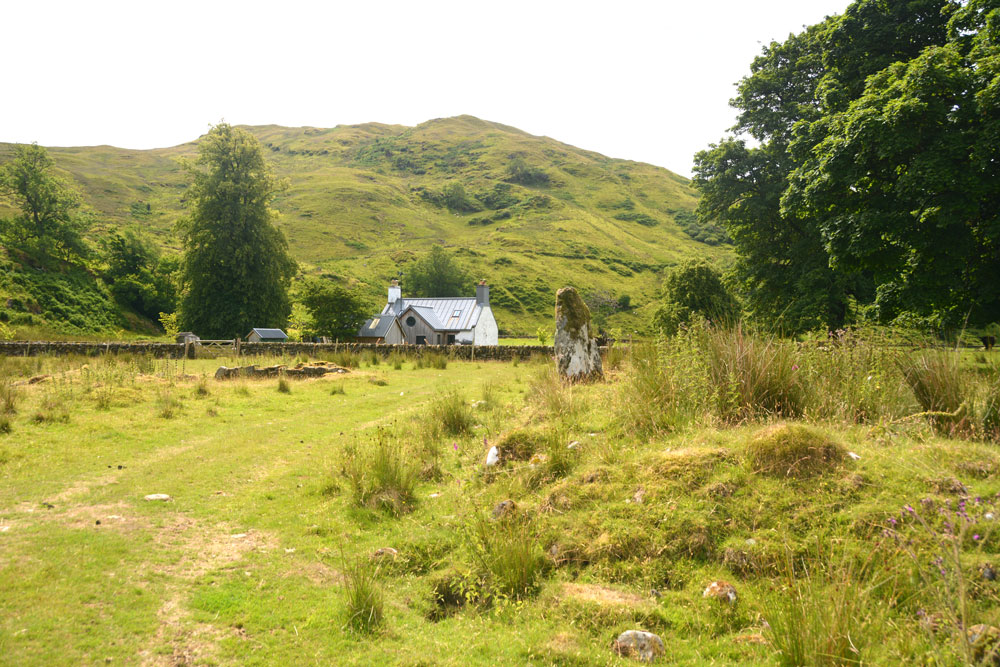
top-left (342, 430), bottom-right (418, 516)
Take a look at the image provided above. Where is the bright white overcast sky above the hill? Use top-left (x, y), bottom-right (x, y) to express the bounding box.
top-left (0, 0), bottom-right (849, 176)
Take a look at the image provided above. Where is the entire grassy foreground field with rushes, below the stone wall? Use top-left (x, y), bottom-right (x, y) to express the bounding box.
top-left (0, 337), bottom-right (1000, 665)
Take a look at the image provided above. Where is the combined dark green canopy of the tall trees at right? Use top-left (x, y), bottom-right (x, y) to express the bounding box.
top-left (694, 0), bottom-right (984, 331)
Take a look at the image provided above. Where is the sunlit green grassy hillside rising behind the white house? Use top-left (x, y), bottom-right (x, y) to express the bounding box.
top-left (0, 116), bottom-right (728, 333)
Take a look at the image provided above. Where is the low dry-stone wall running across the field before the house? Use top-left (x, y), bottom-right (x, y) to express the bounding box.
top-left (0, 341), bottom-right (552, 361)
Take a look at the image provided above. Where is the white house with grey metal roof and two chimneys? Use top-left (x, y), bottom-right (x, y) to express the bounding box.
top-left (358, 280), bottom-right (500, 345)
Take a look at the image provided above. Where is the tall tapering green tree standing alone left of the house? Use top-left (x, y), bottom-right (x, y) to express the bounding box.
top-left (179, 123), bottom-right (296, 338)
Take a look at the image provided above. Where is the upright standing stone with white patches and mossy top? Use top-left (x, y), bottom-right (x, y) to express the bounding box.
top-left (555, 287), bottom-right (604, 382)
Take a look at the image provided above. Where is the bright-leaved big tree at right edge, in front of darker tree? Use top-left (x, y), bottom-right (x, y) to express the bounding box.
top-left (784, 0), bottom-right (1000, 326)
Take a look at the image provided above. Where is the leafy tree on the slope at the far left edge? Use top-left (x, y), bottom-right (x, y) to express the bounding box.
top-left (0, 144), bottom-right (88, 259)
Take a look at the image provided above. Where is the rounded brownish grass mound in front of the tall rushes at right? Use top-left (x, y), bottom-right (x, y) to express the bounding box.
top-left (746, 424), bottom-right (847, 478)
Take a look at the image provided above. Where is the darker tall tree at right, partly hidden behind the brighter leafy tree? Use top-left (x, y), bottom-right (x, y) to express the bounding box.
top-left (694, 0), bottom-right (957, 331)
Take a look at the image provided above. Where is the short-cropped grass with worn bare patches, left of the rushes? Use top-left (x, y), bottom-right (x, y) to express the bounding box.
top-left (0, 362), bottom-right (548, 664)
